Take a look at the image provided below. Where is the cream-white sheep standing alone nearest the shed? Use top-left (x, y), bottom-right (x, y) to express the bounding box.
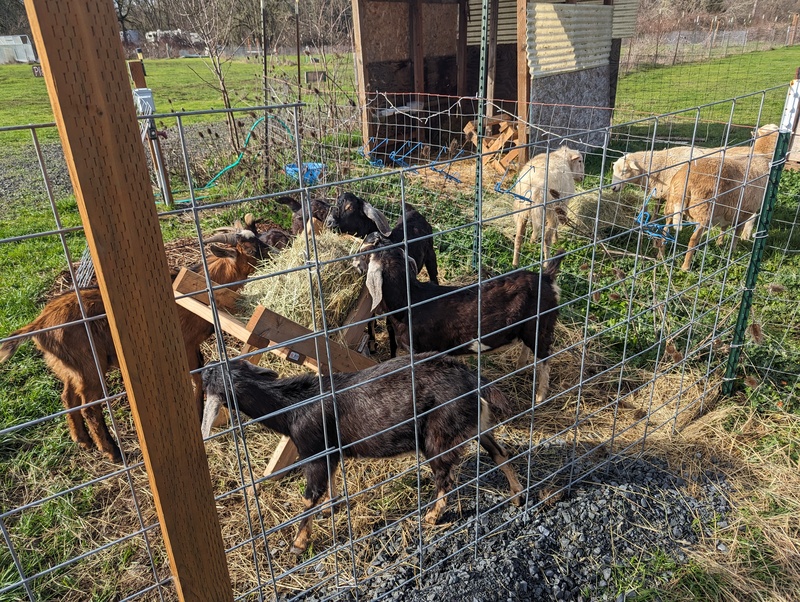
top-left (512, 144), bottom-right (584, 267)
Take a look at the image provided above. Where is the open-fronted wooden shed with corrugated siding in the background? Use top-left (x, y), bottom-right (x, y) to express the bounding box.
top-left (352, 0), bottom-right (639, 159)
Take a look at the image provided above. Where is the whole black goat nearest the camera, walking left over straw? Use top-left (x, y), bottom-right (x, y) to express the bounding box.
top-left (203, 354), bottom-right (522, 554)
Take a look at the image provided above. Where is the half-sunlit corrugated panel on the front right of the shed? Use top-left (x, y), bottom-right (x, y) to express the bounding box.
top-left (528, 3), bottom-right (614, 77)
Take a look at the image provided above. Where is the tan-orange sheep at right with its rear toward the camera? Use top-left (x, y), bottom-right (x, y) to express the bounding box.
top-left (664, 157), bottom-right (764, 271)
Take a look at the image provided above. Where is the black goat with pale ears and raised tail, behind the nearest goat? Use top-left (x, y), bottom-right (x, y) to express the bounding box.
top-left (353, 233), bottom-right (563, 402)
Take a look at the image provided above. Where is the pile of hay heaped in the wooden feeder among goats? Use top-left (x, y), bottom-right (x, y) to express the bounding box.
top-left (240, 232), bottom-right (364, 340)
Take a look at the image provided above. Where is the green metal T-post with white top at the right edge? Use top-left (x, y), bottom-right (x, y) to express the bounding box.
top-left (722, 80), bottom-right (800, 395)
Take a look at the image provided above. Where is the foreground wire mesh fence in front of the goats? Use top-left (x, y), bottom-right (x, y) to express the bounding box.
top-left (0, 72), bottom-right (798, 600)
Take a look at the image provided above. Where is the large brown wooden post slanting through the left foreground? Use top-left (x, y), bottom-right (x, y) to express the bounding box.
top-left (25, 0), bottom-right (233, 602)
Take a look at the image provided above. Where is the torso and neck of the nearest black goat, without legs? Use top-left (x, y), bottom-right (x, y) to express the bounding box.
top-left (217, 354), bottom-right (510, 457)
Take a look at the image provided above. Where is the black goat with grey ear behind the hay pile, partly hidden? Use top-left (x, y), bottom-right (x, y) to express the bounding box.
top-left (325, 192), bottom-right (439, 284)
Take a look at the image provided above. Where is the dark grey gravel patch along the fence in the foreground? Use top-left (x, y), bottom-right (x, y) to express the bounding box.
top-left (299, 458), bottom-right (730, 602)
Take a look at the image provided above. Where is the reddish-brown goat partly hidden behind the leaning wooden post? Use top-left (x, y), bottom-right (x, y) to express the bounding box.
top-left (0, 231), bottom-right (262, 462)
